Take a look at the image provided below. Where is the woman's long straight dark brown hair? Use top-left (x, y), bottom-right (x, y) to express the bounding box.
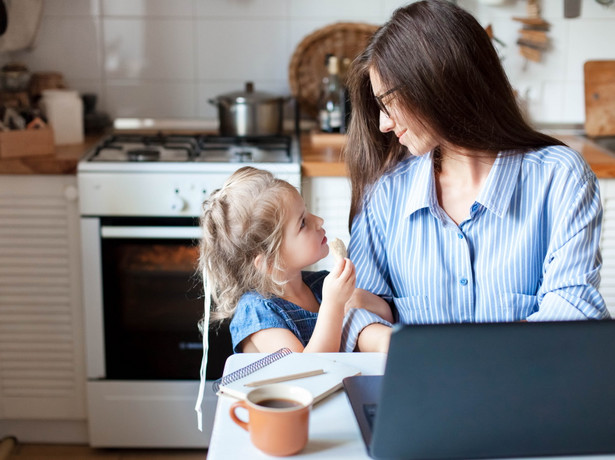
top-left (344, 0), bottom-right (562, 223)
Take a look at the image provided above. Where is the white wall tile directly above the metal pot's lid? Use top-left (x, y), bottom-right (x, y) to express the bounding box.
top-left (197, 19), bottom-right (290, 81)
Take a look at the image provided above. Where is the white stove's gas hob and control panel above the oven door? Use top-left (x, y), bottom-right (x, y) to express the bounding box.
top-left (77, 134), bottom-right (301, 217)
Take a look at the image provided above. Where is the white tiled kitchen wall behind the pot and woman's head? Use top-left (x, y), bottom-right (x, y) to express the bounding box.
top-left (0, 0), bottom-right (615, 123)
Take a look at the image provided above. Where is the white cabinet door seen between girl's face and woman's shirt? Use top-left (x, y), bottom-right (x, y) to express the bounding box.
top-left (302, 177), bottom-right (350, 270)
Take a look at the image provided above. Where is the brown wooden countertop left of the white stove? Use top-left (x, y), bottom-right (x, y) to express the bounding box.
top-left (0, 135), bottom-right (104, 174)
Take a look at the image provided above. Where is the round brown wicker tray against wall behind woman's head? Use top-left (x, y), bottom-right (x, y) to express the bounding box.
top-left (288, 22), bottom-right (379, 118)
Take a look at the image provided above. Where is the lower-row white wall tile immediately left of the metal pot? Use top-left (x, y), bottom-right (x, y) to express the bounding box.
top-left (105, 80), bottom-right (196, 118)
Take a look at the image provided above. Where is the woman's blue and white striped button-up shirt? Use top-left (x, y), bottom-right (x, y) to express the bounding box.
top-left (349, 146), bottom-right (609, 333)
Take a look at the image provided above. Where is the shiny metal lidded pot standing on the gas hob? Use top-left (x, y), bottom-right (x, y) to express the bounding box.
top-left (209, 82), bottom-right (287, 136)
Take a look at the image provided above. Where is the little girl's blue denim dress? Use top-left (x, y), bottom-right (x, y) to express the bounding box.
top-left (230, 270), bottom-right (329, 353)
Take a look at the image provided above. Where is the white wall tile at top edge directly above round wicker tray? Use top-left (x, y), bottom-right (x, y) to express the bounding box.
top-left (288, 0), bottom-right (382, 21)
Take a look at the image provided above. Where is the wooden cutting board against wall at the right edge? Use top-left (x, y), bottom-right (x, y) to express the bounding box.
top-left (584, 60), bottom-right (615, 136)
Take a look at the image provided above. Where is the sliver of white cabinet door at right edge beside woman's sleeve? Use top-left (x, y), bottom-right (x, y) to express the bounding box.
top-left (600, 179), bottom-right (615, 318)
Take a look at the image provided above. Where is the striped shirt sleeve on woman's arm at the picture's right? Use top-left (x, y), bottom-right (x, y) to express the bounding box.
top-left (527, 172), bottom-right (609, 321)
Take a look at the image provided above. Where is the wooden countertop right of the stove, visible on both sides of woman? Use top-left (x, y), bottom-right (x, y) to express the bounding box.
top-left (301, 133), bottom-right (615, 179)
